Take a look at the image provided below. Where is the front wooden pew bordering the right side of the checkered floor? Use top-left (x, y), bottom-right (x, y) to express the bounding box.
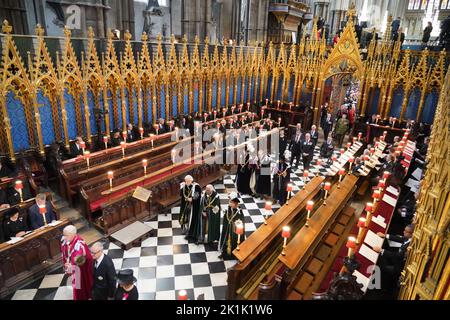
top-left (227, 177), bottom-right (324, 300)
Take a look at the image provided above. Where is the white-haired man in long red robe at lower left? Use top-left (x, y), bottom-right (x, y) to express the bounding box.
top-left (61, 225), bottom-right (94, 300)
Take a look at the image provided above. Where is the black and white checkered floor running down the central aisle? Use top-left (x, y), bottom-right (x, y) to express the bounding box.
top-left (10, 147), bottom-right (337, 300)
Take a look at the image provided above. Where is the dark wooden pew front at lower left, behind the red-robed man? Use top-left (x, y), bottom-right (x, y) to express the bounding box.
top-left (0, 220), bottom-right (69, 297)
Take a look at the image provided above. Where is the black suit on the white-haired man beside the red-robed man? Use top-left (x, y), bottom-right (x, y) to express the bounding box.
top-left (92, 254), bottom-right (116, 300)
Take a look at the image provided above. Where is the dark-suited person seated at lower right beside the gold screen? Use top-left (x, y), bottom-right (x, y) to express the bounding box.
top-left (373, 224), bottom-right (414, 287)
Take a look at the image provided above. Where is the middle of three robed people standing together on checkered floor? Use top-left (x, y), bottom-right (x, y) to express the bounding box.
top-left (202, 184), bottom-right (220, 243)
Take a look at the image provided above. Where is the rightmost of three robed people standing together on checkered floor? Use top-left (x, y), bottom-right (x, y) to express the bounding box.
top-left (219, 194), bottom-right (245, 259)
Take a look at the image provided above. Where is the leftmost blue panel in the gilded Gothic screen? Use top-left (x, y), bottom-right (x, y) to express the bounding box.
top-left (6, 92), bottom-right (30, 152)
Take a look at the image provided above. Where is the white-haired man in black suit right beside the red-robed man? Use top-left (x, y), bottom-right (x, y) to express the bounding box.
top-left (91, 242), bottom-right (116, 300)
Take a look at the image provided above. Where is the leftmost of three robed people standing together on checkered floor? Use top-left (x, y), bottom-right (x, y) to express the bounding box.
top-left (178, 175), bottom-right (202, 238)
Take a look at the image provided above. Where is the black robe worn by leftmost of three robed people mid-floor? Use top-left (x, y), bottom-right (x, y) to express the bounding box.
top-left (182, 182), bottom-right (202, 235)
